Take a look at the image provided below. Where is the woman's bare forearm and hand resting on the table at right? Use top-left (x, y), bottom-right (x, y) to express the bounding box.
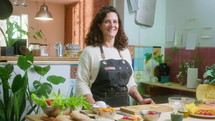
top-left (129, 86), bottom-right (155, 104)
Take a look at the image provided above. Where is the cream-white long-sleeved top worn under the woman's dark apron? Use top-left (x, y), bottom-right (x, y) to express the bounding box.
top-left (76, 46), bottom-right (136, 95)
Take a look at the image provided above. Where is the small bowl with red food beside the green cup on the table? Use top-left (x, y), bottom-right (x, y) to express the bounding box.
top-left (140, 110), bottom-right (161, 121)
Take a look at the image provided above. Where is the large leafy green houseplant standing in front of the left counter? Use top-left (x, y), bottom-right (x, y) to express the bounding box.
top-left (0, 54), bottom-right (65, 121)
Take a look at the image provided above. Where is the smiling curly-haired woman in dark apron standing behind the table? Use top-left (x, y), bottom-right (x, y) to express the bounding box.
top-left (76, 6), bottom-right (154, 107)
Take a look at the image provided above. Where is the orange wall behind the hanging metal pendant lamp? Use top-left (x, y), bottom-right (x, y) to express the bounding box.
top-left (10, 0), bottom-right (64, 56)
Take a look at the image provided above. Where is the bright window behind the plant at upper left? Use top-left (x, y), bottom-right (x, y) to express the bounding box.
top-left (0, 14), bottom-right (28, 46)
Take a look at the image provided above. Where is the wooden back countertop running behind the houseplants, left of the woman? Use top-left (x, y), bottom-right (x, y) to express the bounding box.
top-left (0, 56), bottom-right (79, 65)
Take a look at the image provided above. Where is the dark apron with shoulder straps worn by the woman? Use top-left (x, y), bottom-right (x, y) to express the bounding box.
top-left (91, 47), bottom-right (132, 107)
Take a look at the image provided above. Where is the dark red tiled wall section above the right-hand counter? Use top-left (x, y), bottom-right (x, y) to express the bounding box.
top-left (165, 47), bottom-right (215, 82)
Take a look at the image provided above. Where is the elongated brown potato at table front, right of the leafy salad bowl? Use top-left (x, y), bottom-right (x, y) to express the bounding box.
top-left (70, 111), bottom-right (92, 121)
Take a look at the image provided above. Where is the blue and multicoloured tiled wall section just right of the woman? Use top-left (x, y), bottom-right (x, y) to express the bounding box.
top-left (129, 45), bottom-right (161, 82)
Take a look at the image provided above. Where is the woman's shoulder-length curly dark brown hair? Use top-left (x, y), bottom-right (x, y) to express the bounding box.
top-left (85, 6), bottom-right (128, 50)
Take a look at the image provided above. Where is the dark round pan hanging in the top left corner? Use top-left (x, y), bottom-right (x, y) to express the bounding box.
top-left (0, 0), bottom-right (13, 20)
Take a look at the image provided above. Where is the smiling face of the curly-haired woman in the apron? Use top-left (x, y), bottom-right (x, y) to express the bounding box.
top-left (99, 12), bottom-right (119, 40)
